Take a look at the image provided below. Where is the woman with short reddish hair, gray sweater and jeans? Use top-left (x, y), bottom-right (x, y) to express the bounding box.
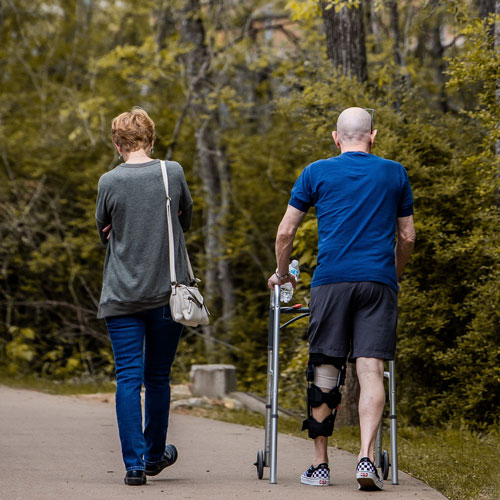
top-left (96, 107), bottom-right (193, 486)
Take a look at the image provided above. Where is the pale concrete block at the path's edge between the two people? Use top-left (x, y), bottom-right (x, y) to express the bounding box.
top-left (190, 365), bottom-right (236, 399)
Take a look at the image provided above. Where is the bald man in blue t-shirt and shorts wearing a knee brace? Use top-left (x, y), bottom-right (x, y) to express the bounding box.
top-left (268, 108), bottom-right (415, 490)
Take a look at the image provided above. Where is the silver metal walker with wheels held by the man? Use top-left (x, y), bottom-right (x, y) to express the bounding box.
top-left (254, 285), bottom-right (399, 484)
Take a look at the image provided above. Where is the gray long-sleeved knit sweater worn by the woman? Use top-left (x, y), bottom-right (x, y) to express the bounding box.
top-left (96, 160), bottom-right (193, 318)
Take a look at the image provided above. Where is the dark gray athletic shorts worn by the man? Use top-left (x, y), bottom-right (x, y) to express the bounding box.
top-left (309, 281), bottom-right (398, 361)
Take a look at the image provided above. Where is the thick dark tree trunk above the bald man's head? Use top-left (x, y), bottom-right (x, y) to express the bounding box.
top-left (320, 2), bottom-right (368, 82)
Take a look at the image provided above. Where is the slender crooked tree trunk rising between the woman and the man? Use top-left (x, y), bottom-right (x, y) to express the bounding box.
top-left (181, 0), bottom-right (235, 359)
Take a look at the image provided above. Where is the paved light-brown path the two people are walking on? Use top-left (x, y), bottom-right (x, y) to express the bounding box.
top-left (0, 386), bottom-right (445, 500)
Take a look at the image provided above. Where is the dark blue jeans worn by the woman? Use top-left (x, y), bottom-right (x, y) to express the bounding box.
top-left (106, 305), bottom-right (183, 471)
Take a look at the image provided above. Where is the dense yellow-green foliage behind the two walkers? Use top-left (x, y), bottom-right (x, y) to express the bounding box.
top-left (0, 0), bottom-right (500, 426)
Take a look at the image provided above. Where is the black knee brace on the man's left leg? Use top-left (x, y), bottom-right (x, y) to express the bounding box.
top-left (302, 361), bottom-right (345, 439)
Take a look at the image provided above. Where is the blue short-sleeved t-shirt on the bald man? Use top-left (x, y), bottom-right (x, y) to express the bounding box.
top-left (289, 152), bottom-right (413, 292)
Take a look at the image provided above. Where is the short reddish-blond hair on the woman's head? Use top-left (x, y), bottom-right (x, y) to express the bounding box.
top-left (111, 106), bottom-right (155, 153)
